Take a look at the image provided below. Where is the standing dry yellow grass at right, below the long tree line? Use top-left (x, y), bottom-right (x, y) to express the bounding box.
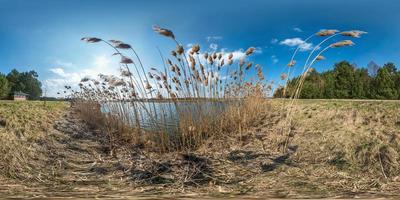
top-left (293, 101), bottom-right (400, 179)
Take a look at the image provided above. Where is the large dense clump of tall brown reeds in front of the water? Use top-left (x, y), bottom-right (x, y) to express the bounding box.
top-left (66, 26), bottom-right (271, 152)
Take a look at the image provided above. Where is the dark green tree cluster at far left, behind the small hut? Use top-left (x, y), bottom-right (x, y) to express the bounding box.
top-left (0, 69), bottom-right (42, 99)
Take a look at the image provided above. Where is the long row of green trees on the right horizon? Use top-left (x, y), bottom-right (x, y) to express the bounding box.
top-left (274, 61), bottom-right (400, 99)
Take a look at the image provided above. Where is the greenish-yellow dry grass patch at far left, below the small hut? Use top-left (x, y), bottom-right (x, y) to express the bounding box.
top-left (0, 101), bottom-right (67, 179)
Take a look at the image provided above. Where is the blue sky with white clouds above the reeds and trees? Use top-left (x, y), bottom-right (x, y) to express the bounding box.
top-left (0, 0), bottom-right (400, 96)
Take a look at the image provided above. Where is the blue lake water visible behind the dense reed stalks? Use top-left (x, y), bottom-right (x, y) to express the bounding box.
top-left (102, 101), bottom-right (233, 133)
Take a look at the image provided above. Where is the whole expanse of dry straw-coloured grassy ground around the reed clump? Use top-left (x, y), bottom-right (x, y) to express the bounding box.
top-left (0, 100), bottom-right (400, 197)
